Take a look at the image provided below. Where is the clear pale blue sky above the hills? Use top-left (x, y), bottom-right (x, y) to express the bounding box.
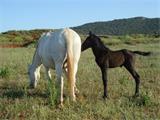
top-left (0, 0), bottom-right (160, 32)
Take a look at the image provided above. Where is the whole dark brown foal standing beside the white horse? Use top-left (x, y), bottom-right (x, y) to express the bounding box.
top-left (81, 32), bottom-right (150, 98)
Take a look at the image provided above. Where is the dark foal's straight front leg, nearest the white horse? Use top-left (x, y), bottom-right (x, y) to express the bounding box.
top-left (100, 66), bottom-right (108, 99)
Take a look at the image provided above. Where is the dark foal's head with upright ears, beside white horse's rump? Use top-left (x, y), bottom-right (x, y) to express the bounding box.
top-left (81, 32), bottom-right (102, 51)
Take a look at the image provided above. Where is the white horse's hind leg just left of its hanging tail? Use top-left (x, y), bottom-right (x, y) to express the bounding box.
top-left (56, 64), bottom-right (64, 106)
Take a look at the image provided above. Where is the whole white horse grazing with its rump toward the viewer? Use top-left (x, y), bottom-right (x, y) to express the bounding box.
top-left (28, 28), bottom-right (81, 104)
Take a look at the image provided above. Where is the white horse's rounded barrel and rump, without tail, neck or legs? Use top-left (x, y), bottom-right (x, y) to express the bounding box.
top-left (37, 29), bottom-right (81, 67)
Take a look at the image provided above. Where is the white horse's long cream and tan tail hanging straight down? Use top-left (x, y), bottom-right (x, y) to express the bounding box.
top-left (65, 29), bottom-right (74, 97)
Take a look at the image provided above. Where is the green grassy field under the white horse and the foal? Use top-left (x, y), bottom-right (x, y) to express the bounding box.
top-left (0, 36), bottom-right (160, 120)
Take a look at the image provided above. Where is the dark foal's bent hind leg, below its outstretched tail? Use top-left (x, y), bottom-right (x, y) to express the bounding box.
top-left (124, 63), bottom-right (140, 96)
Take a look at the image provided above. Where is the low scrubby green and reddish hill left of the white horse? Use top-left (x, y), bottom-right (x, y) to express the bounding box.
top-left (0, 29), bottom-right (51, 47)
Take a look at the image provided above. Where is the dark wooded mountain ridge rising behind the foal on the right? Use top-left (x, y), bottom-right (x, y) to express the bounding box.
top-left (72, 17), bottom-right (160, 35)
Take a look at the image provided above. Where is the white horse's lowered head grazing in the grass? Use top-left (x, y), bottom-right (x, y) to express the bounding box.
top-left (28, 65), bottom-right (37, 88)
